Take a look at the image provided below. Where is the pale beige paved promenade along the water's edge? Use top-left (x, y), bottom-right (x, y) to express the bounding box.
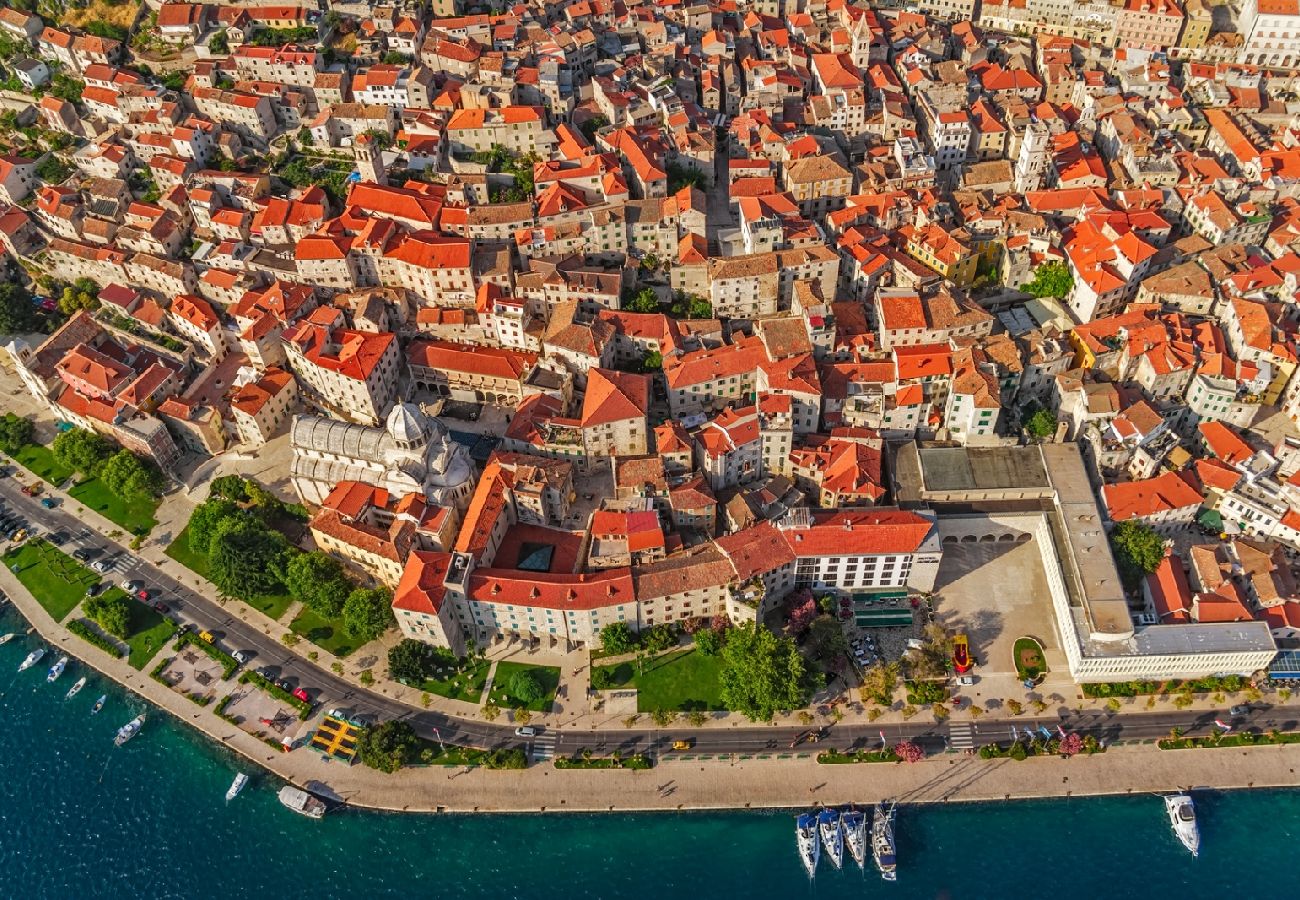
top-left (0, 556), bottom-right (1300, 812)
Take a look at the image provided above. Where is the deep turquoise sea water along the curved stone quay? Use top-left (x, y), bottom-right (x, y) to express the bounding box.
top-left (0, 616), bottom-right (1300, 900)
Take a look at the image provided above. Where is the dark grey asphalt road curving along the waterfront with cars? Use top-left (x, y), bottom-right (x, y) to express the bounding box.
top-left (0, 477), bottom-right (1300, 756)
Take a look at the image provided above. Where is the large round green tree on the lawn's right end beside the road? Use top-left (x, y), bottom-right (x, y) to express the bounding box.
top-left (719, 623), bottom-right (806, 722)
